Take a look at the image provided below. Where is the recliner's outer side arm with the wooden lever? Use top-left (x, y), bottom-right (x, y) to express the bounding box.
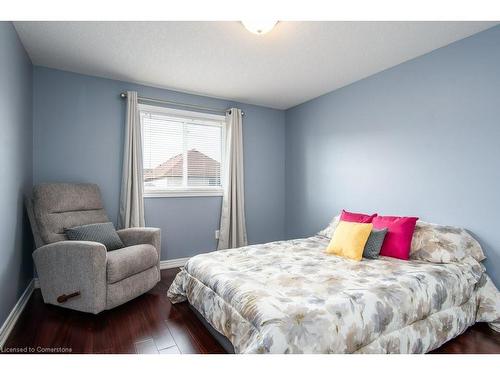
top-left (33, 241), bottom-right (107, 314)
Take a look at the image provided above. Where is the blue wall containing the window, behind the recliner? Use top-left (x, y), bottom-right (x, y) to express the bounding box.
top-left (33, 67), bottom-right (285, 259)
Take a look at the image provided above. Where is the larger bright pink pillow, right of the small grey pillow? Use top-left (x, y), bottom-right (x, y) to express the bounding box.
top-left (372, 216), bottom-right (418, 260)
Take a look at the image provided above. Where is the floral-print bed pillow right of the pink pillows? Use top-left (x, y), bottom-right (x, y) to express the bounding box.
top-left (410, 221), bottom-right (486, 263)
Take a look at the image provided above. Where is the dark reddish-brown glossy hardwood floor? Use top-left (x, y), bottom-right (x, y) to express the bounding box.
top-left (5, 269), bottom-right (500, 354)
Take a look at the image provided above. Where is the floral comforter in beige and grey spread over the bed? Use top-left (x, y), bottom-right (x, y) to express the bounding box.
top-left (168, 235), bottom-right (500, 353)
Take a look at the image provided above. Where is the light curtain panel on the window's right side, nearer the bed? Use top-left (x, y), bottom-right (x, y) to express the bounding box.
top-left (217, 108), bottom-right (247, 250)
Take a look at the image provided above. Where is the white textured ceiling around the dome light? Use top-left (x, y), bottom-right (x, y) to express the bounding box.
top-left (14, 22), bottom-right (497, 109)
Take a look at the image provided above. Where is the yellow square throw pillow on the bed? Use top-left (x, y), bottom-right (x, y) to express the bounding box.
top-left (326, 221), bottom-right (373, 260)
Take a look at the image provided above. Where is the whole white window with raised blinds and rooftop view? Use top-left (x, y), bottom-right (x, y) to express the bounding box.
top-left (139, 105), bottom-right (225, 197)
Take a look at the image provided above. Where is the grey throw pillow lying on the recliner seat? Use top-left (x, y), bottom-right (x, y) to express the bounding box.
top-left (64, 223), bottom-right (125, 251)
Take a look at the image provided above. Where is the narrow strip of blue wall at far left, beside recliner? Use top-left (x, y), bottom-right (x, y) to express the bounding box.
top-left (0, 22), bottom-right (33, 326)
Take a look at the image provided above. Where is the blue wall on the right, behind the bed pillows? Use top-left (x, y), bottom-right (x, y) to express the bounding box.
top-left (286, 27), bottom-right (500, 286)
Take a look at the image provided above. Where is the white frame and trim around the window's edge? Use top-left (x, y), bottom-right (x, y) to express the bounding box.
top-left (138, 103), bottom-right (226, 198)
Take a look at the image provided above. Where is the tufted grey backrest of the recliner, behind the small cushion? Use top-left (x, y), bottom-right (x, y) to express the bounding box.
top-left (33, 183), bottom-right (109, 244)
